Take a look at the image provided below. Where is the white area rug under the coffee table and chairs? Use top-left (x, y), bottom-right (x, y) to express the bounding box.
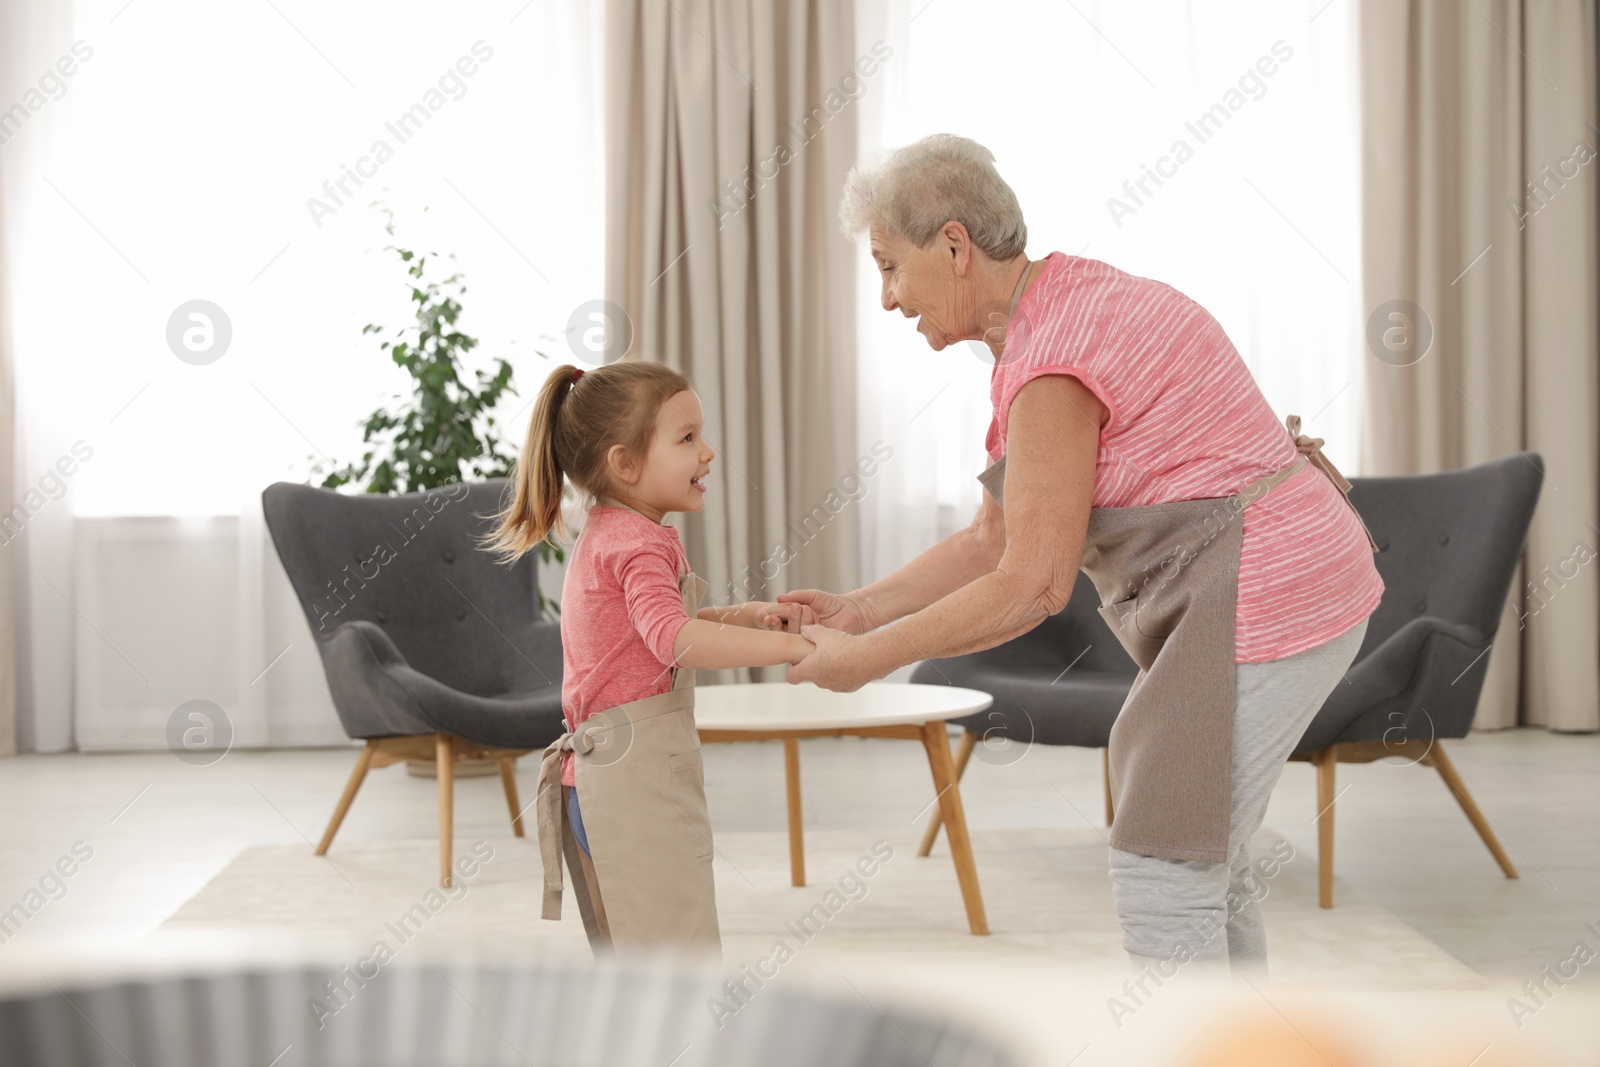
top-left (154, 827), bottom-right (1485, 990)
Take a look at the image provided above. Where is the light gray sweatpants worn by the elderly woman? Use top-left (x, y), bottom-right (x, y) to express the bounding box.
top-left (1110, 619), bottom-right (1366, 976)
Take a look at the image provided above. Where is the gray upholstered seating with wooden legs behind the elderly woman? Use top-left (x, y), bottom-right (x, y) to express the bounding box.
top-left (912, 453), bottom-right (1544, 907)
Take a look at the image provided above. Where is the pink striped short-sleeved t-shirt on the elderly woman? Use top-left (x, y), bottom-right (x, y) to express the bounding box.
top-left (984, 253), bottom-right (1384, 664)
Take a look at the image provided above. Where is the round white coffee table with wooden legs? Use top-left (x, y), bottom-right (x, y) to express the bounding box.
top-left (694, 681), bottom-right (994, 934)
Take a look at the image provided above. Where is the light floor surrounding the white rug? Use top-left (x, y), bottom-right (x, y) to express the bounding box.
top-left (0, 729), bottom-right (1600, 981)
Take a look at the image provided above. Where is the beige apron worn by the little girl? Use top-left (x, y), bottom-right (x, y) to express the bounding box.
top-left (538, 571), bottom-right (722, 958)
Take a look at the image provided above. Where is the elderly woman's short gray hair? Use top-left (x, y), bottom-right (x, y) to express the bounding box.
top-left (838, 133), bottom-right (1027, 261)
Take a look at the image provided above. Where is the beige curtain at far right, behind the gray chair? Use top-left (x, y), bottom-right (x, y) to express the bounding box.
top-left (1362, 0), bottom-right (1600, 731)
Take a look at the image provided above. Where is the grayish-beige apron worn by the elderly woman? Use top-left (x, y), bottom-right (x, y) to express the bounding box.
top-left (978, 416), bottom-right (1378, 862)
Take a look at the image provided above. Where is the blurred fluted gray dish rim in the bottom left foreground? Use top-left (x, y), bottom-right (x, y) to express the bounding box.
top-left (0, 957), bottom-right (1021, 1067)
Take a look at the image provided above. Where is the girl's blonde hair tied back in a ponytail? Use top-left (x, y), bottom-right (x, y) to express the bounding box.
top-left (482, 360), bottom-right (691, 563)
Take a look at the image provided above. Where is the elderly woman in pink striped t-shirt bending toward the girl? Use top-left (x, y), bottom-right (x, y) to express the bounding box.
top-left (779, 134), bottom-right (1384, 976)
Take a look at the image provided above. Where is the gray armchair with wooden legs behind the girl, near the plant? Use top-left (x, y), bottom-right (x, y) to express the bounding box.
top-left (261, 480), bottom-right (565, 886)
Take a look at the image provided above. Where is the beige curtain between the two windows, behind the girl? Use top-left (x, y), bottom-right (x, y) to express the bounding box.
top-left (606, 0), bottom-right (859, 681)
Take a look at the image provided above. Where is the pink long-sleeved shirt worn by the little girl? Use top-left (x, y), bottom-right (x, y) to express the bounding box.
top-left (562, 504), bottom-right (690, 785)
